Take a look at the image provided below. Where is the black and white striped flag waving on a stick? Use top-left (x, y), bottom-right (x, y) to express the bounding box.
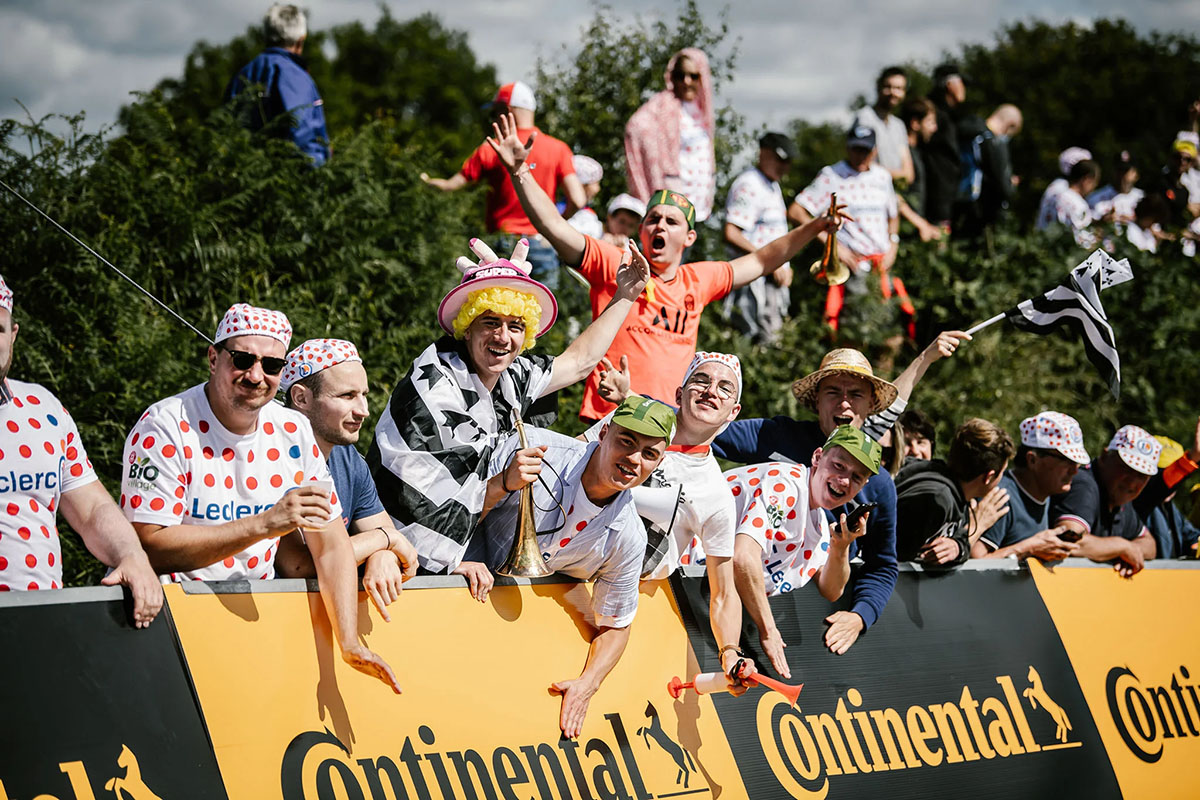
top-left (1004, 249), bottom-right (1133, 397)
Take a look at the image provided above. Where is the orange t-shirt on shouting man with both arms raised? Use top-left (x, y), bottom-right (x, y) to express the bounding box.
top-left (580, 236), bottom-right (733, 420)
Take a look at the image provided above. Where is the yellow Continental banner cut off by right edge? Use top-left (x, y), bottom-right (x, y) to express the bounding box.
top-left (1030, 559), bottom-right (1200, 799)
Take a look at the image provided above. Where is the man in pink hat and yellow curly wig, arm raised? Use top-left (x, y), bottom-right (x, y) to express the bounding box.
top-left (367, 237), bottom-right (649, 602)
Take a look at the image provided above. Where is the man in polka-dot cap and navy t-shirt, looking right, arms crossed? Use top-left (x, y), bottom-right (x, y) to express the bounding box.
top-left (276, 339), bottom-right (416, 622)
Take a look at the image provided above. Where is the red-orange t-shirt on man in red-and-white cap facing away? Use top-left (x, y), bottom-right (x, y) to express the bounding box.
top-left (458, 127), bottom-right (575, 235)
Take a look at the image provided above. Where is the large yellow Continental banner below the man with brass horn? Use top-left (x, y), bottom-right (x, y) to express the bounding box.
top-left (167, 582), bottom-right (746, 800)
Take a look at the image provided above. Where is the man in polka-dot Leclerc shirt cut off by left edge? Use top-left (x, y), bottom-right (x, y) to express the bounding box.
top-left (0, 277), bottom-right (162, 627)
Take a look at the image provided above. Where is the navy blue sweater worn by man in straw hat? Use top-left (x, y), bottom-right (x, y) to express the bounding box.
top-left (713, 416), bottom-right (900, 627)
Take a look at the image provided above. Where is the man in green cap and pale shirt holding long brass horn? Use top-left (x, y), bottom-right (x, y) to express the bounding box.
top-left (470, 395), bottom-right (676, 739)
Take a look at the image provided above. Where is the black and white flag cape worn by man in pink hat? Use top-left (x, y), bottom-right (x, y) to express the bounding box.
top-left (367, 336), bottom-right (554, 572)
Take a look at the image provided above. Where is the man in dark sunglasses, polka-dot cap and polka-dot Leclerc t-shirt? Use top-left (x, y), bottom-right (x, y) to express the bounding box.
top-left (120, 303), bottom-right (400, 693)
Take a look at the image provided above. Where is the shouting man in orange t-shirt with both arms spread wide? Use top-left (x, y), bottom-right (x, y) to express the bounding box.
top-left (488, 113), bottom-right (850, 421)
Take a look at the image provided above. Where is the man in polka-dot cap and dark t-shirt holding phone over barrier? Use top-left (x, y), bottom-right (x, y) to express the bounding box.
top-left (971, 411), bottom-right (1090, 561)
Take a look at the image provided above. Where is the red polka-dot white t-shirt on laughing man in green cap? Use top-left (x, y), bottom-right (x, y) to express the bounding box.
top-left (690, 462), bottom-right (829, 597)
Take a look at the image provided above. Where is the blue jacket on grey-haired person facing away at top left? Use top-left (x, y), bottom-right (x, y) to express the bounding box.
top-left (226, 47), bottom-right (329, 167)
